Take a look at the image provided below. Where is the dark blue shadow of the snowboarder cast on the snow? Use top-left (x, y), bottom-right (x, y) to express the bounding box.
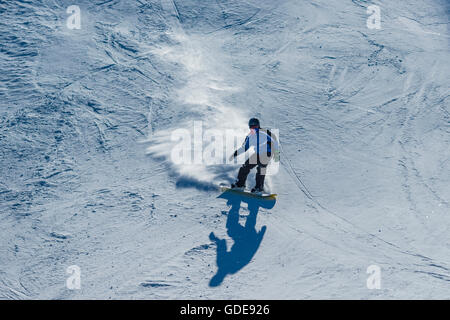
top-left (209, 192), bottom-right (275, 287)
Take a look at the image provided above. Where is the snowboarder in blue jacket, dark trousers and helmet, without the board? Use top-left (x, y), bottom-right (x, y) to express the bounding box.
top-left (230, 118), bottom-right (280, 193)
